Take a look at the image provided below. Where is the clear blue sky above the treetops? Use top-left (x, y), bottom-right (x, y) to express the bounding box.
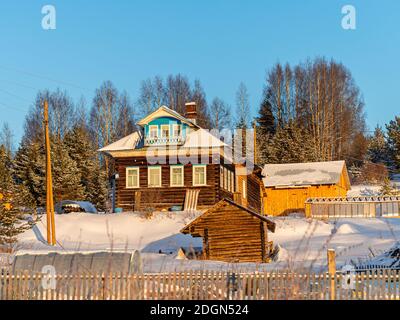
top-left (0, 0), bottom-right (400, 142)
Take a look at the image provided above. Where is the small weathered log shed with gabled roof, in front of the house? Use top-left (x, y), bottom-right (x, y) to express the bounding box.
top-left (181, 199), bottom-right (275, 262)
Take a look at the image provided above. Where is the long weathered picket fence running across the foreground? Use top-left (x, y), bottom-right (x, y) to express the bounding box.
top-left (0, 270), bottom-right (400, 300)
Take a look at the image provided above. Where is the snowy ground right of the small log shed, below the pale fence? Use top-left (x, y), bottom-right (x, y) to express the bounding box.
top-left (269, 217), bottom-right (400, 268)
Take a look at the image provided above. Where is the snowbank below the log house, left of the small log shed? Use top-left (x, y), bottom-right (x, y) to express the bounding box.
top-left (19, 212), bottom-right (202, 252)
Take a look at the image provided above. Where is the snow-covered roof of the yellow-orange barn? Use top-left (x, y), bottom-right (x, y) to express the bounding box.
top-left (262, 161), bottom-right (346, 187)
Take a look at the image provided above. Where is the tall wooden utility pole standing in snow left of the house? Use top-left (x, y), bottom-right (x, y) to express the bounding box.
top-left (44, 100), bottom-right (56, 246)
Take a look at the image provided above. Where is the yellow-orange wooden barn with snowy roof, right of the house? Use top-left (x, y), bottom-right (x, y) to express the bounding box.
top-left (262, 161), bottom-right (351, 216)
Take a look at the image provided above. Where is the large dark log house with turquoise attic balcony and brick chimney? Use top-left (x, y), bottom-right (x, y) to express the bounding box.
top-left (99, 103), bottom-right (262, 212)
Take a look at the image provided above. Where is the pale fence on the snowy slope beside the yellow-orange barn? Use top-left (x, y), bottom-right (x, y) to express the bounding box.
top-left (305, 196), bottom-right (400, 218)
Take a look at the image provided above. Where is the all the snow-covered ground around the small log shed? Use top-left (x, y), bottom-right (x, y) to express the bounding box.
top-left (11, 186), bottom-right (400, 272)
